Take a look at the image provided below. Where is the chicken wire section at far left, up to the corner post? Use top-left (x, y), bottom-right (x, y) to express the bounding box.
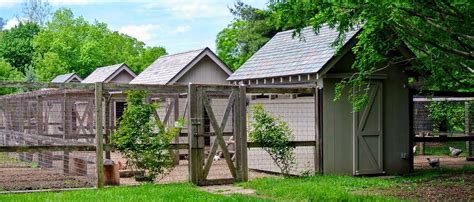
top-left (0, 89), bottom-right (96, 191)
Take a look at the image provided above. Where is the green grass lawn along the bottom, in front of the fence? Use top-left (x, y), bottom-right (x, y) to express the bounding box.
top-left (0, 166), bottom-right (474, 202)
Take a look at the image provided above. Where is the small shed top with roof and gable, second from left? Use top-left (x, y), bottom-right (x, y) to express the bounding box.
top-left (81, 63), bottom-right (137, 83)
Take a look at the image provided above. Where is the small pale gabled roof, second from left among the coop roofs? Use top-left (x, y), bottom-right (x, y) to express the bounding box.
top-left (81, 63), bottom-right (137, 83)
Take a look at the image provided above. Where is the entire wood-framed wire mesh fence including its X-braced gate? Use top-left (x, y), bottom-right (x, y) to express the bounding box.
top-left (0, 83), bottom-right (317, 191)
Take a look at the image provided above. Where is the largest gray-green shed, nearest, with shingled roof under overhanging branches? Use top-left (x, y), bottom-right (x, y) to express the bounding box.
top-left (228, 26), bottom-right (413, 175)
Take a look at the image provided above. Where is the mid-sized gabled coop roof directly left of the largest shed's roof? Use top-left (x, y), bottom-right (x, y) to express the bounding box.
top-left (130, 48), bottom-right (232, 84)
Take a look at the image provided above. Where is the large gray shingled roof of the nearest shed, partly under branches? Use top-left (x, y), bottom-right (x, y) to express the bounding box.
top-left (227, 25), bottom-right (360, 80)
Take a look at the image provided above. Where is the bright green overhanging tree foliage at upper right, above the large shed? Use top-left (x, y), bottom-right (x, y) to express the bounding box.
top-left (271, 0), bottom-right (474, 108)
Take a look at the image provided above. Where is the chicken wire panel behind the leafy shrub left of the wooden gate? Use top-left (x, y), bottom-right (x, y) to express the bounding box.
top-left (105, 91), bottom-right (189, 185)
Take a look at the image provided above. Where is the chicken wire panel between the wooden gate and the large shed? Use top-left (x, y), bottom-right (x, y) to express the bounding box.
top-left (247, 94), bottom-right (315, 175)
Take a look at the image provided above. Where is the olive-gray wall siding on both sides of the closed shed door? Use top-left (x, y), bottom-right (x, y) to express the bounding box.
top-left (323, 54), bottom-right (410, 174)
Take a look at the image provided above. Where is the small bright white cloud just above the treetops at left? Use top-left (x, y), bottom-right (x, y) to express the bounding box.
top-left (119, 24), bottom-right (161, 41)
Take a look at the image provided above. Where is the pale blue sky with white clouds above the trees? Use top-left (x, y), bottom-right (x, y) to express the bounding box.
top-left (0, 0), bottom-right (266, 53)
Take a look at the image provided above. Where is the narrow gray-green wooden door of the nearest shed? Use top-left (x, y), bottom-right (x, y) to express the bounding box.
top-left (353, 81), bottom-right (384, 175)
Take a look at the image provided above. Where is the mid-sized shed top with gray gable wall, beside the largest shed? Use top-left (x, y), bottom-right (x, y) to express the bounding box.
top-left (130, 48), bottom-right (232, 85)
